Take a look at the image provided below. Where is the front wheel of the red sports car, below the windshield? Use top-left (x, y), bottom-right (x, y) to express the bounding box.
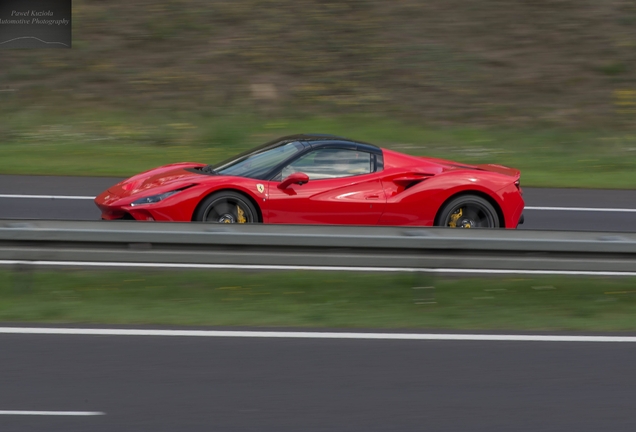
top-left (193, 191), bottom-right (259, 223)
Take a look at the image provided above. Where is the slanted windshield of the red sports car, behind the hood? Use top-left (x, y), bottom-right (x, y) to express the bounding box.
top-left (214, 141), bottom-right (304, 178)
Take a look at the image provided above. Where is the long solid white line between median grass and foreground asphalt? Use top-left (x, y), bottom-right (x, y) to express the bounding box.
top-left (0, 327), bottom-right (636, 343)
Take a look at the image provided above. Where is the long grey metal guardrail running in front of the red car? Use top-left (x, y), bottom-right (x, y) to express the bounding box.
top-left (0, 220), bottom-right (636, 272)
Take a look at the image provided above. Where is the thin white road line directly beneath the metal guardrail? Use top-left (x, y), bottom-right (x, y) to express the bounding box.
top-left (0, 260), bottom-right (636, 276)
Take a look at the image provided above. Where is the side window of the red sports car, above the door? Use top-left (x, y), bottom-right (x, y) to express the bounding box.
top-left (281, 148), bottom-right (374, 180)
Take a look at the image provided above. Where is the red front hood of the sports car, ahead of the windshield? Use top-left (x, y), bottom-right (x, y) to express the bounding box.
top-left (108, 162), bottom-right (205, 198)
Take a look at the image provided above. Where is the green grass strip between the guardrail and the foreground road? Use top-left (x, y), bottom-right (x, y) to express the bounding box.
top-left (0, 270), bottom-right (636, 331)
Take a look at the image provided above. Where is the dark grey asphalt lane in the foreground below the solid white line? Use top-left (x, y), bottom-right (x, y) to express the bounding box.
top-left (0, 335), bottom-right (636, 432)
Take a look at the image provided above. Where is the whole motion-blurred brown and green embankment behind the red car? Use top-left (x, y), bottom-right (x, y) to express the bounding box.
top-left (0, 0), bottom-right (636, 188)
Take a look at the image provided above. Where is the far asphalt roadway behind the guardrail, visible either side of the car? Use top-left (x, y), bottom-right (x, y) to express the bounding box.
top-left (0, 175), bottom-right (636, 232)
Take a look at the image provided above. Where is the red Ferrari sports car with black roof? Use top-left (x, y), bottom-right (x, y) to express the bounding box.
top-left (95, 134), bottom-right (524, 228)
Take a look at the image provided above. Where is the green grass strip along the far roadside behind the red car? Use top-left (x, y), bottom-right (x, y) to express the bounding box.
top-left (0, 111), bottom-right (636, 188)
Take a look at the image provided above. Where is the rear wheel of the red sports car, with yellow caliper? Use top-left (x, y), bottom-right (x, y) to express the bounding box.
top-left (435, 195), bottom-right (501, 228)
